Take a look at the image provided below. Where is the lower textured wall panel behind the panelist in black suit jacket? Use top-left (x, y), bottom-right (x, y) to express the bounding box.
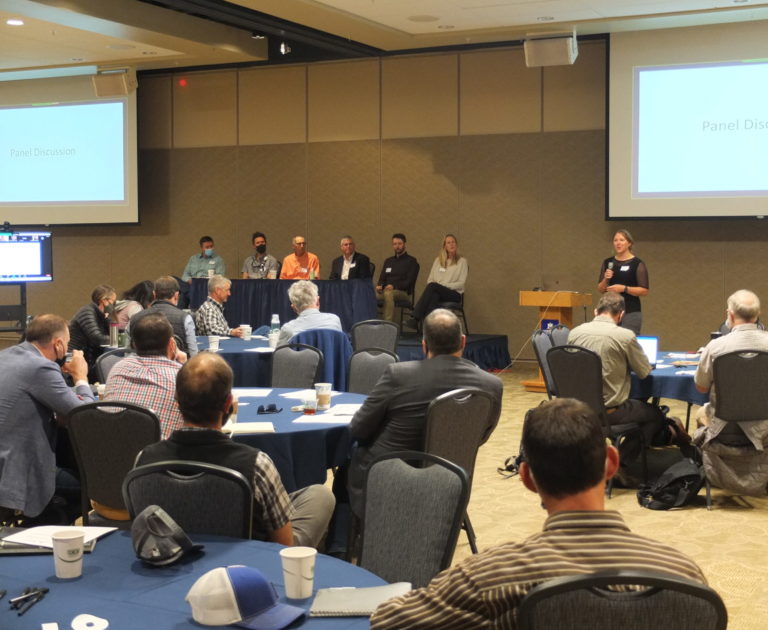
top-left (308, 140), bottom-right (385, 278)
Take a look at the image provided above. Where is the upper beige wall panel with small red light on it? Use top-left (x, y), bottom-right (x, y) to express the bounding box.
top-left (173, 71), bottom-right (237, 148)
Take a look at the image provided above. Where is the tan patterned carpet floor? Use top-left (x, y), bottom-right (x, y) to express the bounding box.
top-left (454, 364), bottom-right (768, 630)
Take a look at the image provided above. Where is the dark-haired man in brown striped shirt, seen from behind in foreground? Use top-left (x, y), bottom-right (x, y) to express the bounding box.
top-left (371, 398), bottom-right (706, 630)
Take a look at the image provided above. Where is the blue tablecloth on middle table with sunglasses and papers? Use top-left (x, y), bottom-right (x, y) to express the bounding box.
top-left (234, 388), bottom-right (365, 492)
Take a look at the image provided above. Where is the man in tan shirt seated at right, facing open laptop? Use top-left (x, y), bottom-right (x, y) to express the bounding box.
top-left (568, 293), bottom-right (690, 446)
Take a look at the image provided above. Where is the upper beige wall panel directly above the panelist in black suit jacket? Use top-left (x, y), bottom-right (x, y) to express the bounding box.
top-left (307, 60), bottom-right (380, 142)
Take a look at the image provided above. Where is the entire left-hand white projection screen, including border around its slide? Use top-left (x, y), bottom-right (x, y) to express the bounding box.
top-left (0, 76), bottom-right (139, 226)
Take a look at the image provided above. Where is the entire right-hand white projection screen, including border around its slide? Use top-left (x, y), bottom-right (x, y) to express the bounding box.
top-left (606, 22), bottom-right (768, 219)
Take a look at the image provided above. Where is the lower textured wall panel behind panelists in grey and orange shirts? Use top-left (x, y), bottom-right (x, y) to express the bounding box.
top-left (233, 144), bottom-right (314, 266)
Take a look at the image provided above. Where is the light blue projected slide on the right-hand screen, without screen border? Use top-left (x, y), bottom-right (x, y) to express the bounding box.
top-left (632, 61), bottom-right (768, 198)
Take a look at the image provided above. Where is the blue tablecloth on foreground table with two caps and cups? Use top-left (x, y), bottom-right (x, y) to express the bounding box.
top-left (0, 532), bottom-right (385, 630)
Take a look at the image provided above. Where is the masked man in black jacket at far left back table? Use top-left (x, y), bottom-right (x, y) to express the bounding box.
top-left (69, 284), bottom-right (117, 380)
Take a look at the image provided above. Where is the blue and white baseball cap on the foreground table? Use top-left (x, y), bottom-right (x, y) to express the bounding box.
top-left (184, 565), bottom-right (306, 630)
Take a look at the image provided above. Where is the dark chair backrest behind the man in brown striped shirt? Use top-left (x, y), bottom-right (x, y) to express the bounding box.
top-left (517, 571), bottom-right (728, 630)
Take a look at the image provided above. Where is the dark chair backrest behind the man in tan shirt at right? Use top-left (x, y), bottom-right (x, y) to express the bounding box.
top-left (547, 345), bottom-right (607, 423)
